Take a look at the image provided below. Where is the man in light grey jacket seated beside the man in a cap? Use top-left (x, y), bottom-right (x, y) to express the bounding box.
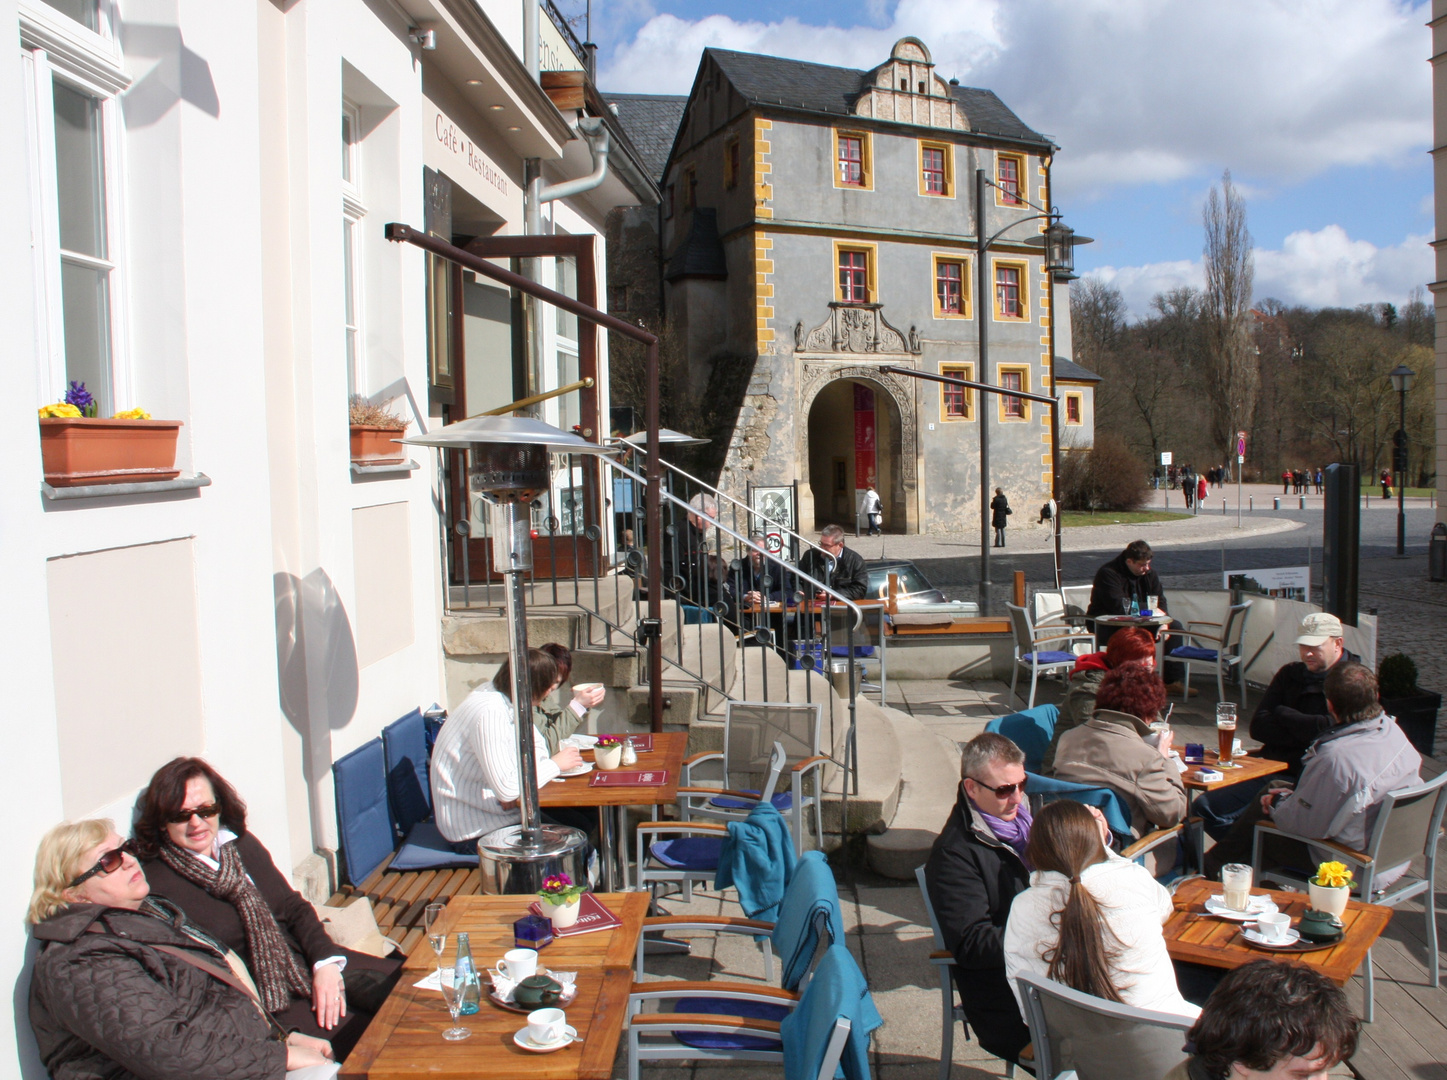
top-left (1205, 662), bottom-right (1422, 885)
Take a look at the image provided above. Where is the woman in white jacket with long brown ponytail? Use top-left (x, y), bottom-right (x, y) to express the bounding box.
top-left (1004, 799), bottom-right (1201, 1019)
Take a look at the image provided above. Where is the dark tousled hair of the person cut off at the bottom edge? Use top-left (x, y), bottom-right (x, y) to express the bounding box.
top-left (1163, 960), bottom-right (1360, 1080)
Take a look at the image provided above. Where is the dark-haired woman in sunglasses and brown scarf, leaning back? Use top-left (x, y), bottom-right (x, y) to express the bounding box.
top-left (132, 757), bottom-right (401, 1060)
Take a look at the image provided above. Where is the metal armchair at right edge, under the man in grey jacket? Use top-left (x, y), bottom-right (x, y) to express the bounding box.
top-left (1252, 772), bottom-right (1447, 1024)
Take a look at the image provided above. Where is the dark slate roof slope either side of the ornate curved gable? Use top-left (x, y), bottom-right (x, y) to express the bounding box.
top-left (703, 49), bottom-right (1051, 145)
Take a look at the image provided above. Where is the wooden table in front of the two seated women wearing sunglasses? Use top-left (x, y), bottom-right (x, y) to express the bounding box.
top-left (340, 892), bottom-right (648, 1080)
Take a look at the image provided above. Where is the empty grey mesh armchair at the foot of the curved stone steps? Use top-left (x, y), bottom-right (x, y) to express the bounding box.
top-left (679, 701), bottom-right (831, 856)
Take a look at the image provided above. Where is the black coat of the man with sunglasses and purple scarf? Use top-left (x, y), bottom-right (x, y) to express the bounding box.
top-left (925, 790), bottom-right (1030, 1061)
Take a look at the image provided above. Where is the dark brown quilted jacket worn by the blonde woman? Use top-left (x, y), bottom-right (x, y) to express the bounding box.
top-left (30, 903), bottom-right (287, 1080)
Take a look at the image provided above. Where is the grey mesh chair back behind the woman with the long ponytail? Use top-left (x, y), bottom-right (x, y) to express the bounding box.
top-left (1016, 973), bottom-right (1194, 1080)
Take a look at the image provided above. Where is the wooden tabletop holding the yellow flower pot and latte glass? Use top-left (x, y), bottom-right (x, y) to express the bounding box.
top-left (1165, 879), bottom-right (1392, 986)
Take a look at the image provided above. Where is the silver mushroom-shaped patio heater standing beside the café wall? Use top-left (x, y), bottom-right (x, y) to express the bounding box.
top-left (402, 417), bottom-right (608, 893)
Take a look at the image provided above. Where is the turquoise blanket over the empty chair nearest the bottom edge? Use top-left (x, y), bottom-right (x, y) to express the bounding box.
top-left (780, 944), bottom-right (884, 1080)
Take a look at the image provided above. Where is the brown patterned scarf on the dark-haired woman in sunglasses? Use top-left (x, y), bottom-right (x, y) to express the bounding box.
top-left (161, 838), bottom-right (311, 1012)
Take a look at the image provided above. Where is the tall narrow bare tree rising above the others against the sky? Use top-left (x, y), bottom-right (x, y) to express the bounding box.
top-left (1201, 169), bottom-right (1260, 469)
